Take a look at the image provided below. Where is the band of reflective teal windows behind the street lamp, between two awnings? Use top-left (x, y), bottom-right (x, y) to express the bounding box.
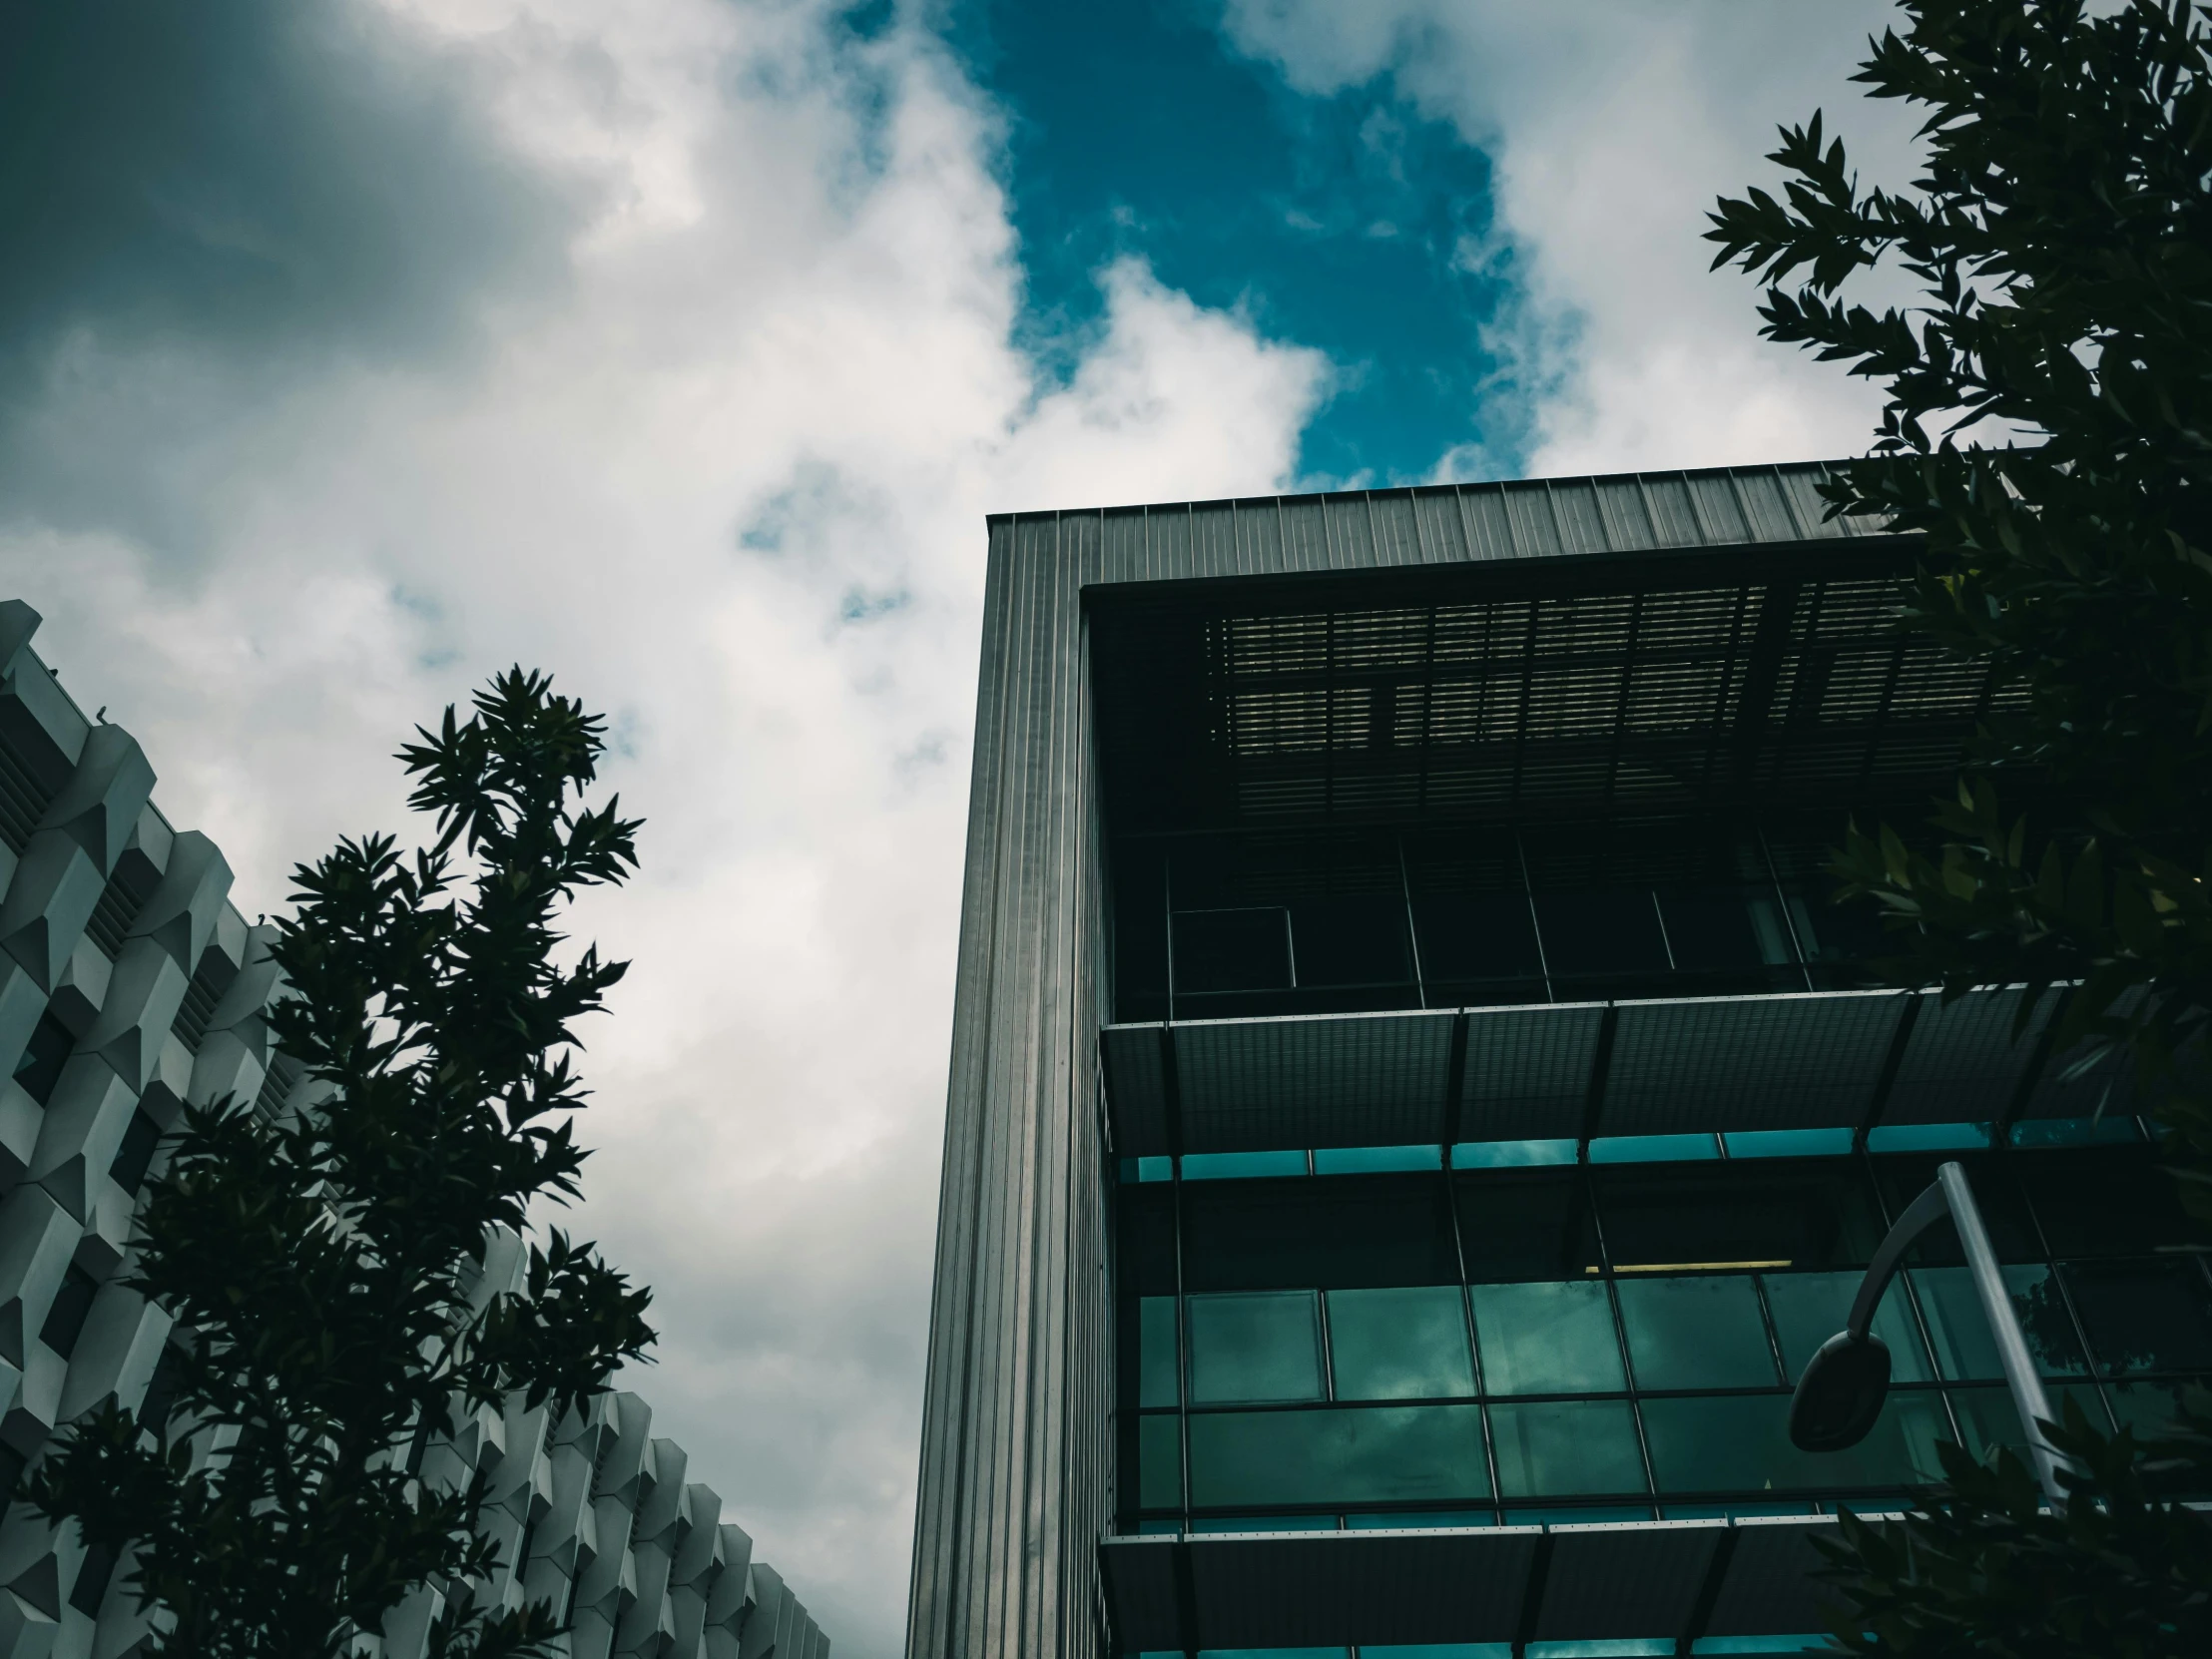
top-left (1115, 1130), bottom-right (2212, 1533)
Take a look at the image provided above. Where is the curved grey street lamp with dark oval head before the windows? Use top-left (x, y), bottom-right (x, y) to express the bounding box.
top-left (1790, 1164), bottom-right (2066, 1508)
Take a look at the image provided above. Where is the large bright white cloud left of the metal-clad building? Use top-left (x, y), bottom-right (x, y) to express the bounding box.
top-left (0, 0), bottom-right (1325, 1657)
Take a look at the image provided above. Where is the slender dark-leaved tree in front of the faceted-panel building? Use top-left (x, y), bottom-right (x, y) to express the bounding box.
top-left (22, 668), bottom-right (653, 1659)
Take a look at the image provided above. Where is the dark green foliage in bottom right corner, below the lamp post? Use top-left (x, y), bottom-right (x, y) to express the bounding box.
top-left (1821, 1393), bottom-right (2212, 1659)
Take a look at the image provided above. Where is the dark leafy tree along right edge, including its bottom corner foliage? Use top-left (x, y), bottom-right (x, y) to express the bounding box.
top-left (1710, 0), bottom-right (2212, 1655)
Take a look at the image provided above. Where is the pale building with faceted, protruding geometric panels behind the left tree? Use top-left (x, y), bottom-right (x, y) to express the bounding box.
top-left (0, 600), bottom-right (830, 1659)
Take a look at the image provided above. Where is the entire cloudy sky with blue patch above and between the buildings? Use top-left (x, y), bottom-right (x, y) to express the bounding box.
top-left (0, 0), bottom-right (1909, 1659)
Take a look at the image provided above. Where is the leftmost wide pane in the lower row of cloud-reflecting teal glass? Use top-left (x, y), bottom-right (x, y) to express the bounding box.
top-left (1190, 1404), bottom-right (1491, 1508)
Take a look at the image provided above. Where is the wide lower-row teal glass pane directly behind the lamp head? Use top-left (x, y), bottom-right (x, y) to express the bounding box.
top-left (1636, 1391), bottom-right (1951, 1493)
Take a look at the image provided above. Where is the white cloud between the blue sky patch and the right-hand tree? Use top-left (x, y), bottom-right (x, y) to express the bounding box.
top-left (1223, 0), bottom-right (1909, 475)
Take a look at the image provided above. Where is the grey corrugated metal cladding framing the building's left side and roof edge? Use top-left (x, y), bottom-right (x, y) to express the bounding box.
top-left (907, 464), bottom-right (1902, 1659)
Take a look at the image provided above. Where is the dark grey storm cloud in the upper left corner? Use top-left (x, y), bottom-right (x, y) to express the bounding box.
top-left (0, 0), bottom-right (584, 533)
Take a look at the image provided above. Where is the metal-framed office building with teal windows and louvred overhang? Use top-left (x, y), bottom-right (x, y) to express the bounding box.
top-left (909, 467), bottom-right (2212, 1659)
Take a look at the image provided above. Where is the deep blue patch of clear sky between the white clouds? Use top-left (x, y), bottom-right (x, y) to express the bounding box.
top-left (949, 0), bottom-right (1528, 484)
